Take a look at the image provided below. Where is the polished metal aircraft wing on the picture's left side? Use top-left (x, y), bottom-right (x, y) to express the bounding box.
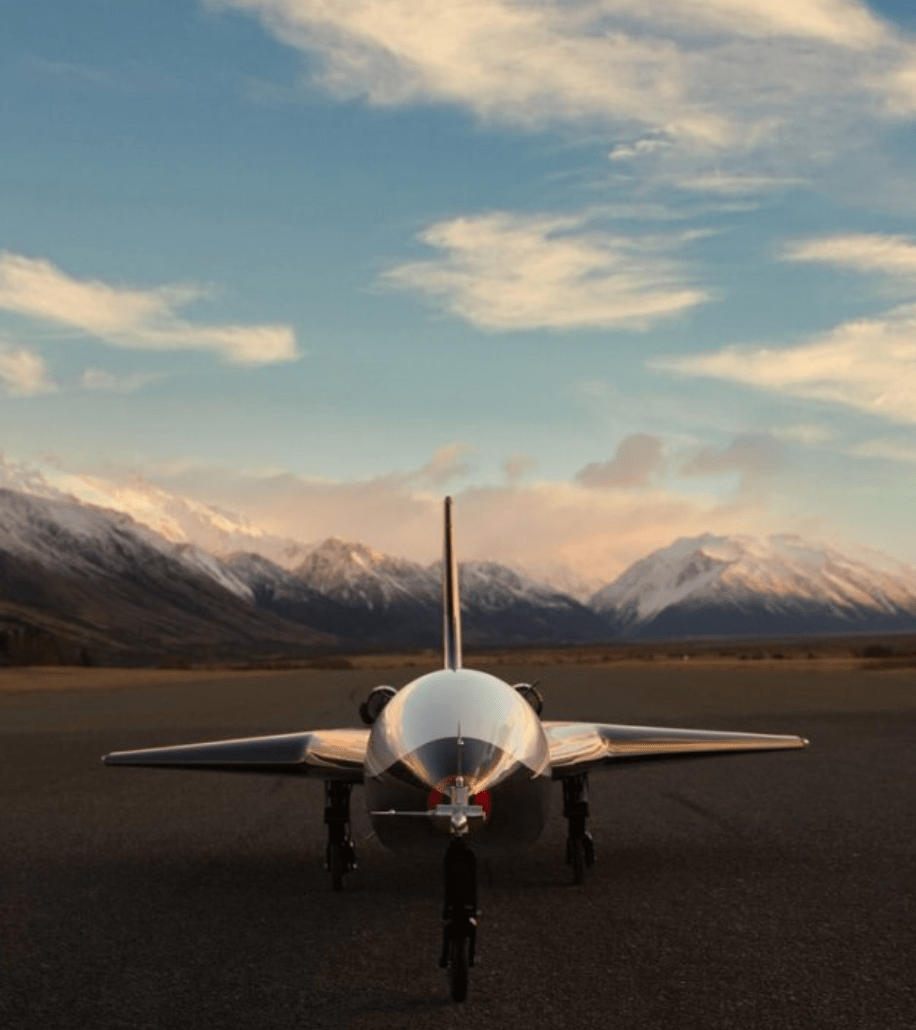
top-left (102, 729), bottom-right (369, 783)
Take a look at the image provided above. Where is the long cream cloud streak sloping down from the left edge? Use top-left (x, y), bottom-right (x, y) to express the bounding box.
top-left (0, 252), bottom-right (297, 366)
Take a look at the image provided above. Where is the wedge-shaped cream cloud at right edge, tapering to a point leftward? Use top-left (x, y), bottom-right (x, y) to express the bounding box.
top-left (650, 305), bottom-right (916, 423)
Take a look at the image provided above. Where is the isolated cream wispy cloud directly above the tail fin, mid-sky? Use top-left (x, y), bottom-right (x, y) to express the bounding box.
top-left (383, 211), bottom-right (709, 331)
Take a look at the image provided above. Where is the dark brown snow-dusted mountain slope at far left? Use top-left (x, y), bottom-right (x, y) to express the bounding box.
top-left (0, 489), bottom-right (331, 661)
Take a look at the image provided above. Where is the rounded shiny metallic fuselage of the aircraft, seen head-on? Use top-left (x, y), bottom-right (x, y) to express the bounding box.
top-left (363, 668), bottom-right (551, 852)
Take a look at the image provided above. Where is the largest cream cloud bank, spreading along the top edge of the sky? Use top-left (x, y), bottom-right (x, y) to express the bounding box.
top-left (208, 0), bottom-right (916, 192)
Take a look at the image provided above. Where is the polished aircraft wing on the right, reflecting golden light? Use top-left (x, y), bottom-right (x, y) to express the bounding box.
top-left (543, 722), bottom-right (808, 780)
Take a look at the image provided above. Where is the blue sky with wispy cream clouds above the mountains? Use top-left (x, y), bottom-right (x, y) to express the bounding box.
top-left (0, 0), bottom-right (916, 582)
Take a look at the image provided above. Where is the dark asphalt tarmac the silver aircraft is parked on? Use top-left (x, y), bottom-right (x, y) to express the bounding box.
top-left (0, 662), bottom-right (916, 1030)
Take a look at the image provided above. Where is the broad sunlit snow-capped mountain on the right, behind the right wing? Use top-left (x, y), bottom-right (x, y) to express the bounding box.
top-left (589, 535), bottom-right (916, 637)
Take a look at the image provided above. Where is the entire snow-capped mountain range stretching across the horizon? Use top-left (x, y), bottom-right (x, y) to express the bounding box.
top-left (0, 489), bottom-right (916, 664)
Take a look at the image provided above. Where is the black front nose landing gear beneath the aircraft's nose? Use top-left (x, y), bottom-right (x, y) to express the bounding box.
top-left (439, 836), bottom-right (477, 1001)
